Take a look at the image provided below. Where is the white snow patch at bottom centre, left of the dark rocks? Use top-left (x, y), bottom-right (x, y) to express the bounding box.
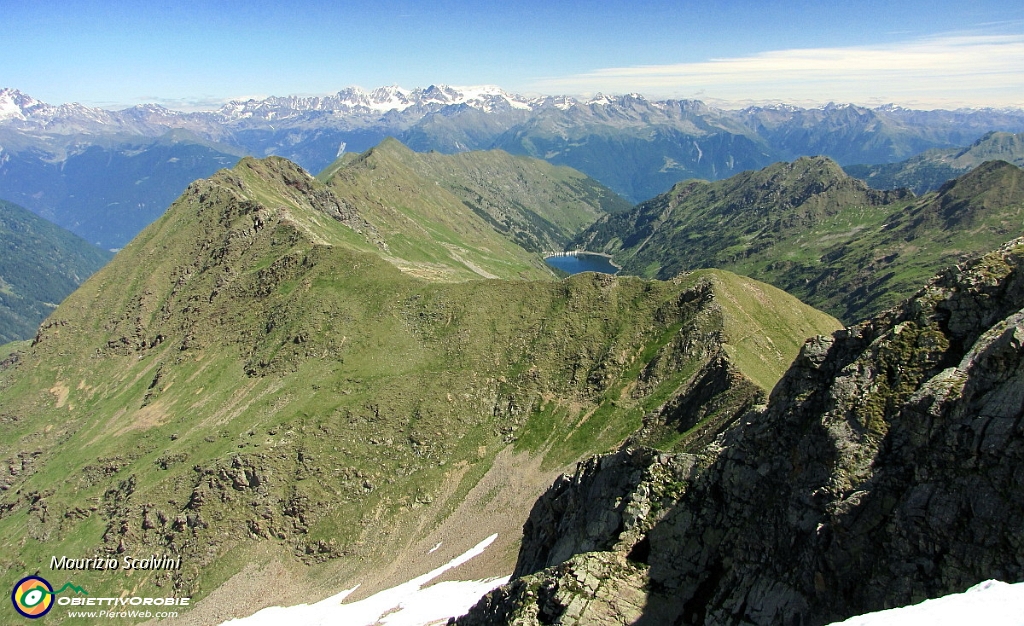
top-left (222, 535), bottom-right (509, 626)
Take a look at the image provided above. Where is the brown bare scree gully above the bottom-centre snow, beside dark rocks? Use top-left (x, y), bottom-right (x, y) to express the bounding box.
top-left (160, 447), bottom-right (566, 626)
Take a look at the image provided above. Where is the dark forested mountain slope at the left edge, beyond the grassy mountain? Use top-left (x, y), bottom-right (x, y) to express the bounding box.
top-left (0, 200), bottom-right (113, 343)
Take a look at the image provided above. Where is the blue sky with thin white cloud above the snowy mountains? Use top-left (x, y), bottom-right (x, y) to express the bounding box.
top-left (0, 0), bottom-right (1024, 109)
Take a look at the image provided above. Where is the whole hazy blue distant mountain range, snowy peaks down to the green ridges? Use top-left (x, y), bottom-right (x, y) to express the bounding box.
top-left (8, 85), bottom-right (1024, 255)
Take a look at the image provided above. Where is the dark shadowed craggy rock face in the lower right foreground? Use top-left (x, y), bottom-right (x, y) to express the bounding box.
top-left (458, 240), bottom-right (1024, 625)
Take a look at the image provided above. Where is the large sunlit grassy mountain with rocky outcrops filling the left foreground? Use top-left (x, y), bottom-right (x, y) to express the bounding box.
top-left (0, 154), bottom-right (838, 623)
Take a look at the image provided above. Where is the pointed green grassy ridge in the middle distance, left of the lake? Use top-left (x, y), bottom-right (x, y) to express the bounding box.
top-left (318, 138), bottom-right (628, 278)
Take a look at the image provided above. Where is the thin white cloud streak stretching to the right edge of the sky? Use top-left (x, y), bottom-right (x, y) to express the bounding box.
top-left (532, 34), bottom-right (1024, 107)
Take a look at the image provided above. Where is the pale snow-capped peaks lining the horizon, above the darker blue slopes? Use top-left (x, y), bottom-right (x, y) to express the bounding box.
top-left (6, 85), bottom-right (1024, 152)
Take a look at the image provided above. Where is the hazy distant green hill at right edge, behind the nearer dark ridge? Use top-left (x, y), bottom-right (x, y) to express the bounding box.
top-left (843, 132), bottom-right (1024, 195)
